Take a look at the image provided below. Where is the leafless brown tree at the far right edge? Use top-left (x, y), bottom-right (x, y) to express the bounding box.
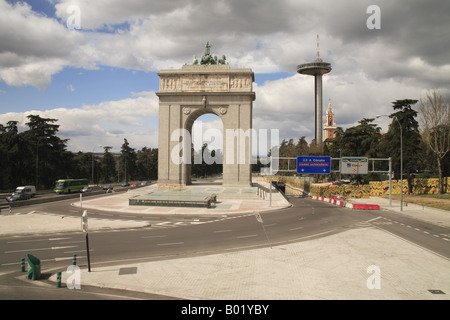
top-left (419, 90), bottom-right (450, 194)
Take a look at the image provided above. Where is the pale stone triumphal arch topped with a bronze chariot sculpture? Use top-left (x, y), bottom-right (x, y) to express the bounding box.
top-left (156, 43), bottom-right (255, 188)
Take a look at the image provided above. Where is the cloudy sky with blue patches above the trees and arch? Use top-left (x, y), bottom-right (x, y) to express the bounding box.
top-left (0, 0), bottom-right (450, 152)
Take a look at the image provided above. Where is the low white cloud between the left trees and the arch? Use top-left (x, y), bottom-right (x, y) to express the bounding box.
top-left (0, 91), bottom-right (158, 151)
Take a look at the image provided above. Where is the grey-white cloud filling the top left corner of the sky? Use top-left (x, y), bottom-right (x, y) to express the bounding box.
top-left (0, 1), bottom-right (88, 89)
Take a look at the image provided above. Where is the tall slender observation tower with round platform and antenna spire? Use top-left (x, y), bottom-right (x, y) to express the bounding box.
top-left (297, 35), bottom-right (331, 144)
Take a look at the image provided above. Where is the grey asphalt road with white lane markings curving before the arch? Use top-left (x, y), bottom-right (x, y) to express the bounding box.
top-left (0, 192), bottom-right (450, 299)
